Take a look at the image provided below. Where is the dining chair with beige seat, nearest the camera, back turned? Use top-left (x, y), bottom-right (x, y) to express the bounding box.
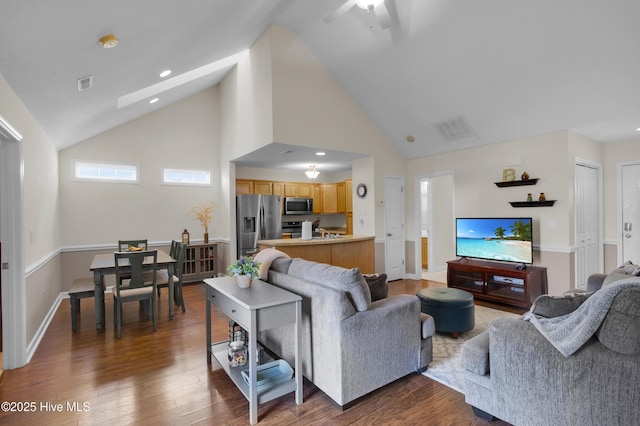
top-left (113, 250), bottom-right (158, 339)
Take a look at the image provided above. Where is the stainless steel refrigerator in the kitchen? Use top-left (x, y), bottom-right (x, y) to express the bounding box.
top-left (236, 194), bottom-right (282, 257)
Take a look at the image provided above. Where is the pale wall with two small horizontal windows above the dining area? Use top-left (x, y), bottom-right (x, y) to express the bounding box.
top-left (60, 87), bottom-right (226, 247)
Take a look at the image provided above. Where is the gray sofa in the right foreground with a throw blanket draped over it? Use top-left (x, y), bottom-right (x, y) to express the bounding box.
top-left (462, 264), bottom-right (640, 426)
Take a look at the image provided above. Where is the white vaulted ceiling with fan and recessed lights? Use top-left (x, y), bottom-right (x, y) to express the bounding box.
top-left (0, 0), bottom-right (640, 172)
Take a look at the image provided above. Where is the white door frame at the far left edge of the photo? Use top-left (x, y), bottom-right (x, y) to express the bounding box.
top-left (0, 137), bottom-right (27, 369)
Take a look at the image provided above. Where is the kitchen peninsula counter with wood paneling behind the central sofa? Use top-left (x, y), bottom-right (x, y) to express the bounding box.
top-left (258, 235), bottom-right (375, 274)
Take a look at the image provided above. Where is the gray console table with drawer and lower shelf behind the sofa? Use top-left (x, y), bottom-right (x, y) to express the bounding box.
top-left (204, 277), bottom-right (302, 424)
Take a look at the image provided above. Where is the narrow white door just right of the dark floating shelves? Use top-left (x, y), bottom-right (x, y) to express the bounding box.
top-left (574, 164), bottom-right (602, 288)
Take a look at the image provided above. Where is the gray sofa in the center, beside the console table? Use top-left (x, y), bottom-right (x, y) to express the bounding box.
top-left (258, 257), bottom-right (435, 408)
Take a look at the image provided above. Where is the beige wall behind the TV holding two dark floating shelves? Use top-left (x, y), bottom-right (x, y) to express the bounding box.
top-left (405, 131), bottom-right (573, 294)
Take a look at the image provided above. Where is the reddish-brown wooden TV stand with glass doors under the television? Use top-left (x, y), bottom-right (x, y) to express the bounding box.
top-left (447, 258), bottom-right (547, 309)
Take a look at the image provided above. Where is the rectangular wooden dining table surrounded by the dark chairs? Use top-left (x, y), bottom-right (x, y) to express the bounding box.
top-left (89, 250), bottom-right (176, 331)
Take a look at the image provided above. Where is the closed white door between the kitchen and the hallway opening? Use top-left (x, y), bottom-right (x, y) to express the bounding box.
top-left (384, 176), bottom-right (405, 281)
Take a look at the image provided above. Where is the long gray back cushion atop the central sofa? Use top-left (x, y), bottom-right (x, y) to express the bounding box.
top-left (288, 258), bottom-right (371, 311)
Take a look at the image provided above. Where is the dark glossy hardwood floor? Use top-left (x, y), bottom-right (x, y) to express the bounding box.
top-left (0, 280), bottom-right (506, 426)
